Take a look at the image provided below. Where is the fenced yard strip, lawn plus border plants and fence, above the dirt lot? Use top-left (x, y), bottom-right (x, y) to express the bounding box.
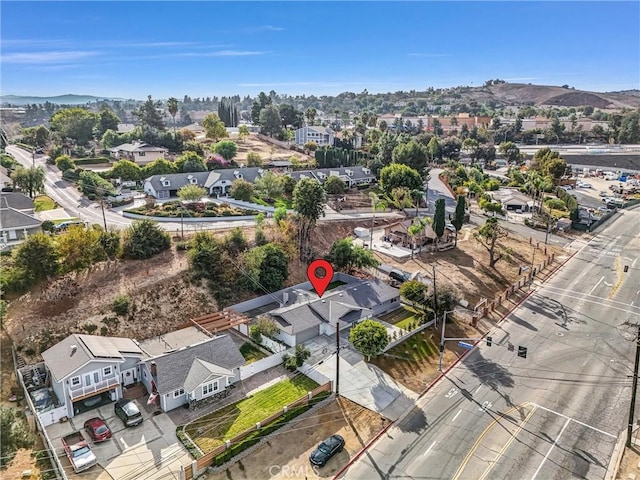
top-left (177, 374), bottom-right (331, 469)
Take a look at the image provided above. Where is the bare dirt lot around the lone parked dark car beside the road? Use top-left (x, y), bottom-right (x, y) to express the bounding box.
top-left (207, 398), bottom-right (384, 480)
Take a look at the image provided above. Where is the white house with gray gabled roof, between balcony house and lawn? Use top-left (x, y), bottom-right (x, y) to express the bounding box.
top-left (141, 335), bottom-right (246, 412)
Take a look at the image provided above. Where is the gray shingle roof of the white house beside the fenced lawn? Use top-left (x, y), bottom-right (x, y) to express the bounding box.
top-left (145, 335), bottom-right (245, 394)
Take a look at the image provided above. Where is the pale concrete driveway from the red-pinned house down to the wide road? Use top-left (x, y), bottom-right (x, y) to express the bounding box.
top-left (301, 332), bottom-right (418, 420)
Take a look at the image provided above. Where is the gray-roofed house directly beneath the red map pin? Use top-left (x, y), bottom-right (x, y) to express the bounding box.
top-left (265, 279), bottom-right (400, 347)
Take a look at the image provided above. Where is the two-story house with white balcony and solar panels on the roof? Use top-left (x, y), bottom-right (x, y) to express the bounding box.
top-left (42, 334), bottom-right (144, 417)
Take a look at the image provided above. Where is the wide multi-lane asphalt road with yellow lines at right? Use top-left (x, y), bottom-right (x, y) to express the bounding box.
top-left (343, 209), bottom-right (640, 480)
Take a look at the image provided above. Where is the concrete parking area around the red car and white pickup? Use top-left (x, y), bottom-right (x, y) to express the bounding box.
top-left (46, 403), bottom-right (191, 480)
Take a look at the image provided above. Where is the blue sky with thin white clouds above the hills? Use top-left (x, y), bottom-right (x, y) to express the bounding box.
top-left (0, 1), bottom-right (640, 99)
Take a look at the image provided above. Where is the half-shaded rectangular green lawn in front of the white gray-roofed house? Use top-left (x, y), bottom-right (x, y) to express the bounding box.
top-left (186, 376), bottom-right (318, 453)
